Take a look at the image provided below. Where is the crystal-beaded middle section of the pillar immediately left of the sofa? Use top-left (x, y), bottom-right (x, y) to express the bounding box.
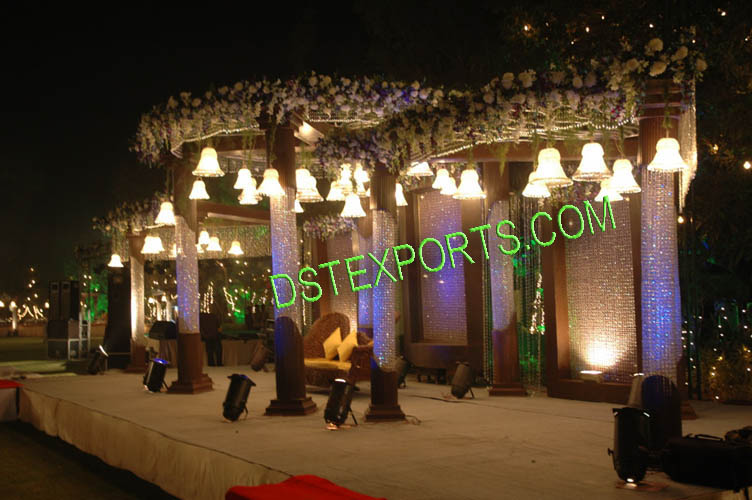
top-left (269, 186), bottom-right (303, 329)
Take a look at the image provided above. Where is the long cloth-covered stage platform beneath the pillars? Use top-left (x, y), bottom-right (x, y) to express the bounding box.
top-left (16, 367), bottom-right (752, 500)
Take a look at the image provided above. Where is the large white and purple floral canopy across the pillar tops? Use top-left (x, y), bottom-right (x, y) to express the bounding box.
top-left (134, 29), bottom-right (707, 178)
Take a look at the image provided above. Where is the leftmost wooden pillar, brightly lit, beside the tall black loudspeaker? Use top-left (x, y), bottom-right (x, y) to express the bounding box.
top-left (125, 234), bottom-right (146, 373)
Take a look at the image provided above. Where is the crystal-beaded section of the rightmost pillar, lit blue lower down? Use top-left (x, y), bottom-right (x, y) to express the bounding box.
top-left (642, 169), bottom-right (682, 381)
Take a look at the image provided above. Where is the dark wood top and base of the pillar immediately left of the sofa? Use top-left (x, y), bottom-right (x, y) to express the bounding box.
top-left (265, 124), bottom-right (316, 416)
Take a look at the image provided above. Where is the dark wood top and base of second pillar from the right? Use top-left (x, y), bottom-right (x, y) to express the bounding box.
top-left (483, 162), bottom-right (527, 396)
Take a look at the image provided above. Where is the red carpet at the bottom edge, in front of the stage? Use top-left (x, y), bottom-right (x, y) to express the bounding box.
top-left (225, 475), bottom-right (386, 500)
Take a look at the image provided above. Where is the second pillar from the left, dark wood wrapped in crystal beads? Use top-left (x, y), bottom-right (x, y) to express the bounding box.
top-left (167, 152), bottom-right (212, 394)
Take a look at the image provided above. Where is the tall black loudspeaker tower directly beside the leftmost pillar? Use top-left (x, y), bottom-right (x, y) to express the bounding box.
top-left (103, 267), bottom-right (131, 353)
